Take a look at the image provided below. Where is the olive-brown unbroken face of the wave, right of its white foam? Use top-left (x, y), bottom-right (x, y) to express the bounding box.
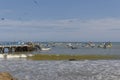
top-left (27, 54), bottom-right (120, 61)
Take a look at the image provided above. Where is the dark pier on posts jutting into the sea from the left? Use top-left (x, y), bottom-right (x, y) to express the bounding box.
top-left (0, 43), bottom-right (40, 53)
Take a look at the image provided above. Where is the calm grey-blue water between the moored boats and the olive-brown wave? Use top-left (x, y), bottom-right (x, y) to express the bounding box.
top-left (40, 42), bottom-right (120, 55)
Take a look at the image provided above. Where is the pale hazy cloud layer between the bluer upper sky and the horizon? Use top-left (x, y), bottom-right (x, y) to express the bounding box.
top-left (0, 18), bottom-right (120, 40)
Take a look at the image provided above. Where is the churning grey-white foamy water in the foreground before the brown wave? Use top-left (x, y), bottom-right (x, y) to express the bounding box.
top-left (0, 59), bottom-right (120, 80)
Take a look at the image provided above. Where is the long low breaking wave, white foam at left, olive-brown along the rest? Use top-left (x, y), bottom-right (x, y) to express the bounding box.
top-left (0, 53), bottom-right (120, 61)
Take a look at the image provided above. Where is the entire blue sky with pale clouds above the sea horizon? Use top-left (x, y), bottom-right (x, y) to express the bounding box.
top-left (0, 0), bottom-right (120, 41)
